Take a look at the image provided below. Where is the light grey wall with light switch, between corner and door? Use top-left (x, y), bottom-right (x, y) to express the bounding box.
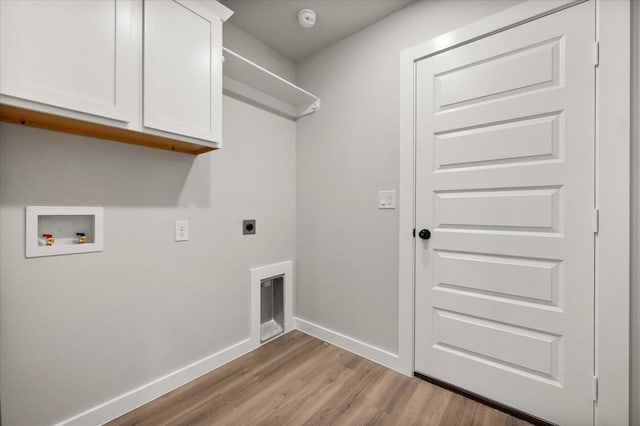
top-left (296, 0), bottom-right (517, 353)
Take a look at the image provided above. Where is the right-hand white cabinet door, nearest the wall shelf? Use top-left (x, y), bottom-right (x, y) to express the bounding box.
top-left (143, 0), bottom-right (222, 142)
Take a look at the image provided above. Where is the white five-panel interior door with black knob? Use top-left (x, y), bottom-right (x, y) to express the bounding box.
top-left (415, 2), bottom-right (595, 425)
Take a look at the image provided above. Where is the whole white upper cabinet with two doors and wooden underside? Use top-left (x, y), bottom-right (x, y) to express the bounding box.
top-left (0, 0), bottom-right (233, 154)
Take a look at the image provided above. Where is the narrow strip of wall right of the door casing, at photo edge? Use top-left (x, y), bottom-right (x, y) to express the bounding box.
top-left (630, 0), bottom-right (640, 425)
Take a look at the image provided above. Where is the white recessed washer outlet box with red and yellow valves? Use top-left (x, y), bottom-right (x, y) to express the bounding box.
top-left (25, 206), bottom-right (104, 257)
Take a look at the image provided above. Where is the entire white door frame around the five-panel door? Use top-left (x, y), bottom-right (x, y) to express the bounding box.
top-left (398, 0), bottom-right (631, 425)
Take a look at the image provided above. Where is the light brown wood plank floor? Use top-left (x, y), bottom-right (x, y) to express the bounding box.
top-left (109, 331), bottom-right (529, 426)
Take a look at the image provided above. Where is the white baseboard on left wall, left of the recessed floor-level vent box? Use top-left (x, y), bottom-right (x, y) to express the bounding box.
top-left (56, 339), bottom-right (255, 426)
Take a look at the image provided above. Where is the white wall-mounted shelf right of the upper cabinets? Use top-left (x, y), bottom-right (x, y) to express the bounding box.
top-left (222, 47), bottom-right (320, 120)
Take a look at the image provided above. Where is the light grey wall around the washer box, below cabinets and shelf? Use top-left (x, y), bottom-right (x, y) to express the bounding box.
top-left (0, 97), bottom-right (295, 425)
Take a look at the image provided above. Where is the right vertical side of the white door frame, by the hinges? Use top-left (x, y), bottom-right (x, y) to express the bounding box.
top-left (595, 0), bottom-right (631, 425)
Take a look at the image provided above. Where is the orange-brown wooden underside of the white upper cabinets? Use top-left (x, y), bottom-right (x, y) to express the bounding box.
top-left (0, 104), bottom-right (216, 155)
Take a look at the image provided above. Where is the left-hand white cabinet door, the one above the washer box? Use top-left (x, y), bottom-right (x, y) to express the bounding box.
top-left (0, 0), bottom-right (137, 122)
